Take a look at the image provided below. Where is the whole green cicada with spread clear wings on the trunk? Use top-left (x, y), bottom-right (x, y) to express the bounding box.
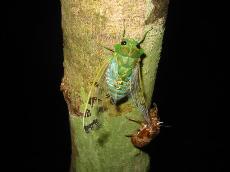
top-left (83, 29), bottom-right (152, 133)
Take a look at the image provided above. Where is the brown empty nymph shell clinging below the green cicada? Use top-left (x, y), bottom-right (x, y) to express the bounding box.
top-left (129, 107), bottom-right (160, 148)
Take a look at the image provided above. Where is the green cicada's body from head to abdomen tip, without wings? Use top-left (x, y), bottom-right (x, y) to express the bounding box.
top-left (106, 39), bottom-right (143, 104)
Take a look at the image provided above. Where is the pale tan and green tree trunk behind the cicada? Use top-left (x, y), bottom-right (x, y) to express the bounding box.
top-left (61, 0), bottom-right (168, 172)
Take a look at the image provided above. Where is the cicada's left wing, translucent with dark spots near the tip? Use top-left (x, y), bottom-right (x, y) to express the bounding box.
top-left (83, 61), bottom-right (109, 133)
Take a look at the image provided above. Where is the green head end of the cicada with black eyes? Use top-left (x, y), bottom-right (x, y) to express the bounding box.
top-left (114, 39), bottom-right (144, 58)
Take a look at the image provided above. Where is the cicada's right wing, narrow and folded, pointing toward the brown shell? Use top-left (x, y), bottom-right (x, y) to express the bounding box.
top-left (130, 64), bottom-right (150, 123)
